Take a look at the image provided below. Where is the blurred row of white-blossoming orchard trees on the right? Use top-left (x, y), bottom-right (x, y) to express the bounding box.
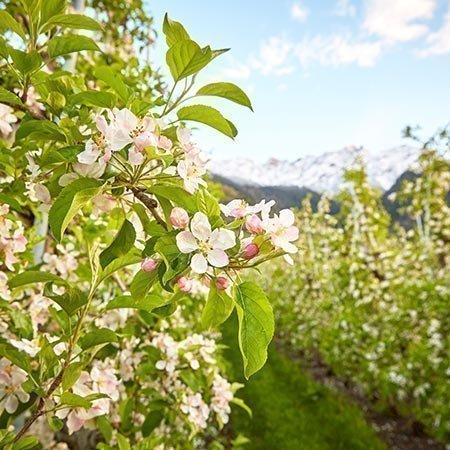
top-left (266, 149), bottom-right (450, 438)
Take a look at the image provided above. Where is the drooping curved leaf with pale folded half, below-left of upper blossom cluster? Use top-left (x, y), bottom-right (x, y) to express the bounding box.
top-left (48, 178), bottom-right (102, 241)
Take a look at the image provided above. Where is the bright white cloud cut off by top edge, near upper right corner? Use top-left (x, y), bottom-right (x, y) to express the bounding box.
top-left (363, 0), bottom-right (436, 43)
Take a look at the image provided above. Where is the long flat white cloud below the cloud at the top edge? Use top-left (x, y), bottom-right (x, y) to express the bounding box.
top-left (295, 34), bottom-right (382, 67)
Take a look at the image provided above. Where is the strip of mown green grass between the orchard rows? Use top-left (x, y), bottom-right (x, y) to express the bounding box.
top-left (223, 318), bottom-right (386, 450)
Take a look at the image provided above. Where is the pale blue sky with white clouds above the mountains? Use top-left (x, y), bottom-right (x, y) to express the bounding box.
top-left (149, 0), bottom-right (450, 160)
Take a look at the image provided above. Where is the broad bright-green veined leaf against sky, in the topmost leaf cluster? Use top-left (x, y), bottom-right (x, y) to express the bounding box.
top-left (166, 40), bottom-right (212, 81)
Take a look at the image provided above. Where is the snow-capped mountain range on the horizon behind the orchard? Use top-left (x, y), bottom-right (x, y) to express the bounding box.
top-left (210, 146), bottom-right (420, 194)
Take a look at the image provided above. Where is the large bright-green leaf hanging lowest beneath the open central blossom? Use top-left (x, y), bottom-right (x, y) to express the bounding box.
top-left (235, 281), bottom-right (274, 379)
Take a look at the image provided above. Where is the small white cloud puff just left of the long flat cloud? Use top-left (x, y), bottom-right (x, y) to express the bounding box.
top-left (251, 36), bottom-right (294, 76)
